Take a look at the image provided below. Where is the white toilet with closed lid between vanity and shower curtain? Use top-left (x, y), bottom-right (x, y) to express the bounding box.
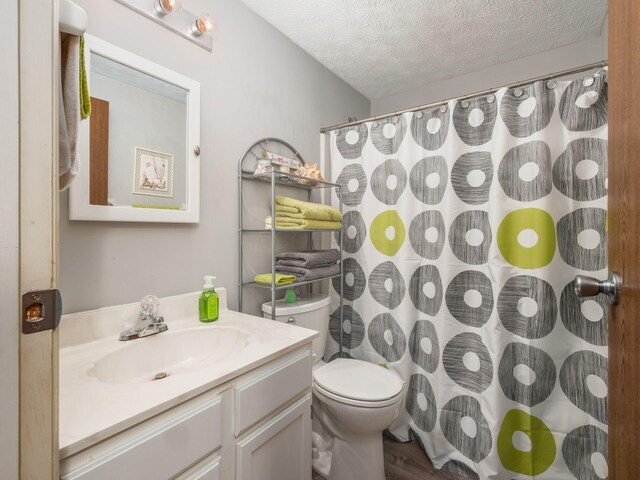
top-left (262, 294), bottom-right (403, 480)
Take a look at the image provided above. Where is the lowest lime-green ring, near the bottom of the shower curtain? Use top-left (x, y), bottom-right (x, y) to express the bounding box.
top-left (498, 409), bottom-right (556, 476)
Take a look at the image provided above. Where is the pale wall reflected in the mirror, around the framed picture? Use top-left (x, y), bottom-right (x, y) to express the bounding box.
top-left (90, 72), bottom-right (187, 209)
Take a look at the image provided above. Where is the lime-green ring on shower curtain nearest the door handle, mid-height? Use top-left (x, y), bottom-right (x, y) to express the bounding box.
top-left (498, 208), bottom-right (556, 269)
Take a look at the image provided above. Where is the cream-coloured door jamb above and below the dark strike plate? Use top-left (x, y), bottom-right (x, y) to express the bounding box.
top-left (12, 0), bottom-right (59, 480)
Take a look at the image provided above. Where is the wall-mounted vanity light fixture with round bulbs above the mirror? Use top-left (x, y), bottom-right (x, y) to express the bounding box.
top-left (115, 0), bottom-right (216, 51)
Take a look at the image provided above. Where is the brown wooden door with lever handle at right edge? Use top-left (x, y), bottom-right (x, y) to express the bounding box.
top-left (609, 0), bottom-right (640, 480)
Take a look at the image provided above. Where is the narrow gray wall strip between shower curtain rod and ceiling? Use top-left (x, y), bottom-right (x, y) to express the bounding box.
top-left (371, 19), bottom-right (608, 115)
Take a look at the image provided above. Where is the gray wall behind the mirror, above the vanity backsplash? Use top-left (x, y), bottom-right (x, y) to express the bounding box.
top-left (60, 0), bottom-right (370, 312)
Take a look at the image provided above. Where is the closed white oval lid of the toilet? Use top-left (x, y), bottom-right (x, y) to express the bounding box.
top-left (313, 358), bottom-right (402, 402)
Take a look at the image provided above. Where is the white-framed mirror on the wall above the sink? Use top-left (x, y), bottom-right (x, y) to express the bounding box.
top-left (69, 35), bottom-right (200, 223)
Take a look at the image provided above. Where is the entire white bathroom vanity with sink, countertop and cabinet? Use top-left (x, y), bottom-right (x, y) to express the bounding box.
top-left (60, 289), bottom-right (317, 480)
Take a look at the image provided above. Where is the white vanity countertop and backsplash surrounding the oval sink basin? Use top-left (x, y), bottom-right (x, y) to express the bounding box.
top-left (59, 289), bottom-right (318, 459)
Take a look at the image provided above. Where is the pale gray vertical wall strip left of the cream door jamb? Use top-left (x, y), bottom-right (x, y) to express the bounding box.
top-left (0, 0), bottom-right (20, 479)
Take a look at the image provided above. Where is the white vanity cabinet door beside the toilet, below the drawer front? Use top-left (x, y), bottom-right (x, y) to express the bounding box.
top-left (236, 394), bottom-right (311, 480)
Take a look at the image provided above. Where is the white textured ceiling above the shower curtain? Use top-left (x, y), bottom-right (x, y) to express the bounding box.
top-left (243, 0), bottom-right (607, 99)
